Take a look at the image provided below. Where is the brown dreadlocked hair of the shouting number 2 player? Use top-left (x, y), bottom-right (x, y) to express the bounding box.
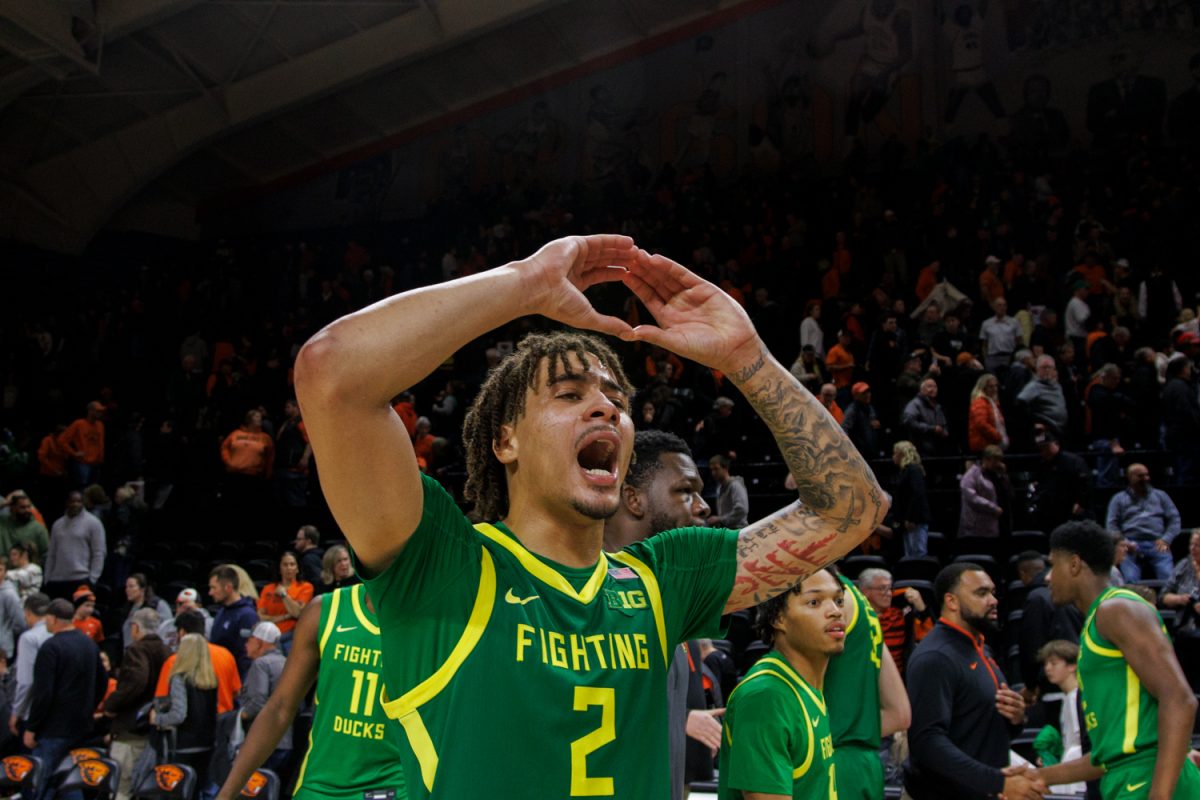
top-left (462, 331), bottom-right (632, 521)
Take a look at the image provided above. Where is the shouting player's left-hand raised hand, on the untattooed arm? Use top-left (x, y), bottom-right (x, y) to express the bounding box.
top-left (517, 234), bottom-right (637, 338)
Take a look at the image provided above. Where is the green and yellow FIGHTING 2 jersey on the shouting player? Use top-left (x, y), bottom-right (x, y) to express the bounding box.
top-left (367, 479), bottom-right (737, 800)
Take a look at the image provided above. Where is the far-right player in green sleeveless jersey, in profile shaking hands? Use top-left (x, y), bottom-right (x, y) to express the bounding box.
top-left (1038, 522), bottom-right (1200, 800)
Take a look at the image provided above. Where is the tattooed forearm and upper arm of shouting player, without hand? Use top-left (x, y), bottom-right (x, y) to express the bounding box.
top-left (726, 357), bottom-right (888, 610)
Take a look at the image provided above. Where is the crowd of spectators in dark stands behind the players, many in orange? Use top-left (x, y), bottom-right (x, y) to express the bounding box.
top-left (0, 73), bottom-right (1200, 796)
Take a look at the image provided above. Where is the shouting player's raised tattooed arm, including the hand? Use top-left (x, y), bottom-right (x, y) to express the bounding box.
top-left (625, 252), bottom-right (888, 612)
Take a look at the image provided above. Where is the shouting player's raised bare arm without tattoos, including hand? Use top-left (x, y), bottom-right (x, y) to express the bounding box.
top-left (295, 235), bottom-right (636, 571)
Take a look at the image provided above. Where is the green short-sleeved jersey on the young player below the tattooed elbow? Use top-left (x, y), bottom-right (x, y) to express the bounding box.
top-left (716, 650), bottom-right (838, 800)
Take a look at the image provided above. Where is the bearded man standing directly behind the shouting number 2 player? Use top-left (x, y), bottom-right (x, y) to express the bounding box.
top-left (604, 431), bottom-right (721, 800)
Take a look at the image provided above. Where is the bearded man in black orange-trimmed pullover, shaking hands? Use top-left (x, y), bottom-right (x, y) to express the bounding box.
top-left (905, 563), bottom-right (1046, 800)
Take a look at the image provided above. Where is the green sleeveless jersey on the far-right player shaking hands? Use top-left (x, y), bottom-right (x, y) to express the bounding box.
top-left (1076, 588), bottom-right (1166, 768)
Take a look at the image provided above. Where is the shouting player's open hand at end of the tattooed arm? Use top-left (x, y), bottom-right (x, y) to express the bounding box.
top-left (623, 251), bottom-right (763, 380)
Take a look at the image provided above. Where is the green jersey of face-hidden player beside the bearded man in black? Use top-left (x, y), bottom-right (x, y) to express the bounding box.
top-left (822, 576), bottom-right (883, 750)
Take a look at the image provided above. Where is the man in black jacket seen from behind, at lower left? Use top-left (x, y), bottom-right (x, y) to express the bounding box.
top-left (25, 597), bottom-right (108, 800)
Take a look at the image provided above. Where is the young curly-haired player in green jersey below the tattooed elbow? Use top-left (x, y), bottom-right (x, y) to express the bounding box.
top-left (716, 570), bottom-right (846, 800)
